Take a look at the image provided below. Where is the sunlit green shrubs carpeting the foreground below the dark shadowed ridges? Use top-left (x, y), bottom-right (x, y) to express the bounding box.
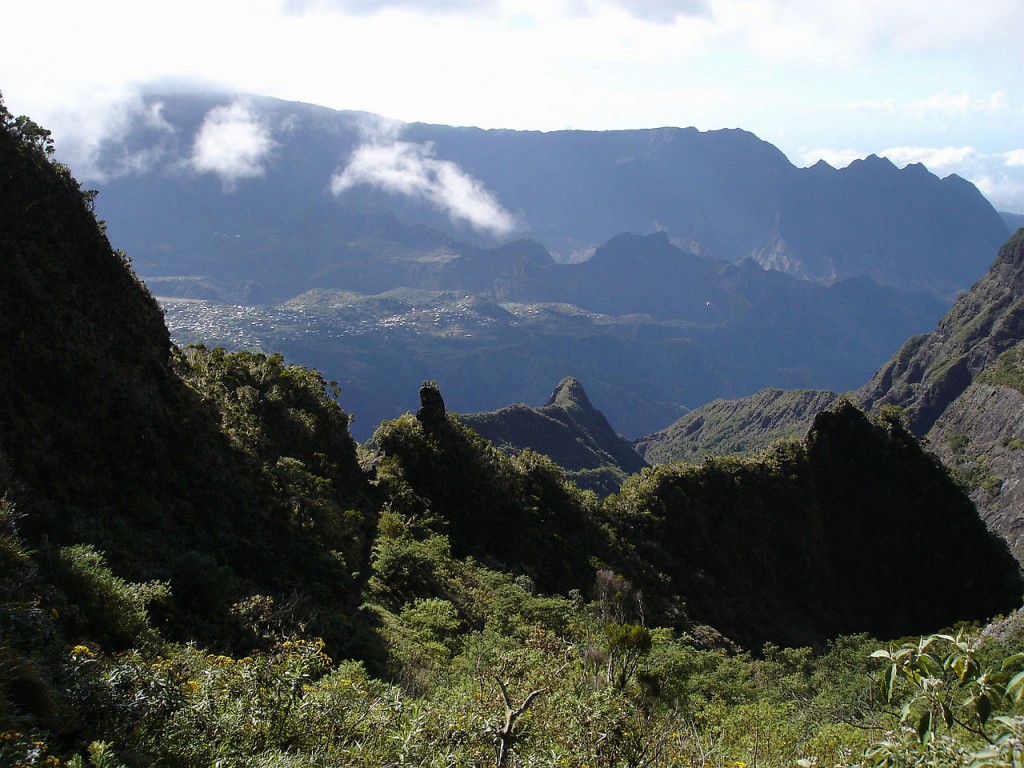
top-left (6, 507), bottom-right (1024, 768)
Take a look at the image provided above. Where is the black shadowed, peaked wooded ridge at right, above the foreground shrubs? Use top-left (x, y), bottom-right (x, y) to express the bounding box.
top-left (609, 400), bottom-right (1020, 647)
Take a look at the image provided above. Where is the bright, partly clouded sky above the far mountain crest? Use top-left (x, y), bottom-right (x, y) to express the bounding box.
top-left (0, 0), bottom-right (1024, 213)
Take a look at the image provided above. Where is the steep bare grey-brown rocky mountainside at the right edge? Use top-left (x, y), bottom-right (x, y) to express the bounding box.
top-left (856, 229), bottom-right (1024, 560)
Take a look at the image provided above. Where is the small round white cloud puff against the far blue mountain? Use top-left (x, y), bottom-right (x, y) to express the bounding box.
top-left (190, 101), bottom-right (274, 189)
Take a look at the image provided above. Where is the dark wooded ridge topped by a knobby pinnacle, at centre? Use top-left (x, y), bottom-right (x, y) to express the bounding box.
top-left (374, 383), bottom-right (606, 593)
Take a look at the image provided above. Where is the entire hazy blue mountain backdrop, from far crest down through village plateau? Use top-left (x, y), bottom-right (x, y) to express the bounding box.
top-left (74, 93), bottom-right (1009, 440)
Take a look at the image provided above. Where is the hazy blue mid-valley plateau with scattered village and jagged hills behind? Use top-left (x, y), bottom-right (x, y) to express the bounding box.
top-left (158, 233), bottom-right (942, 439)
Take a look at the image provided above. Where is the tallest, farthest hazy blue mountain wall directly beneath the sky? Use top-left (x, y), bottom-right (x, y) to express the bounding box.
top-left (91, 93), bottom-right (1009, 301)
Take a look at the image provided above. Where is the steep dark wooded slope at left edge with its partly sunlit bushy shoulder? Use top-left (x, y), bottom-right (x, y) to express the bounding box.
top-left (0, 93), bottom-right (375, 663)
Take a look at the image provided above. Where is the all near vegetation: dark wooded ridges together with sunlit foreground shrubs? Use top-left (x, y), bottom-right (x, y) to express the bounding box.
top-left (0, 93), bottom-right (1024, 768)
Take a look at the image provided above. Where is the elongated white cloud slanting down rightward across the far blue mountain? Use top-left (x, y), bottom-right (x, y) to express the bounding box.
top-left (331, 140), bottom-right (515, 236)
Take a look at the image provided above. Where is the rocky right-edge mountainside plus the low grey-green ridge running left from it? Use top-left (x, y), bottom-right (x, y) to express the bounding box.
top-left (637, 228), bottom-right (1024, 561)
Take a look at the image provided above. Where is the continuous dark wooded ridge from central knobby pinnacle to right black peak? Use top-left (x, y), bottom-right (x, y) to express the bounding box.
top-left (364, 386), bottom-right (1021, 648)
